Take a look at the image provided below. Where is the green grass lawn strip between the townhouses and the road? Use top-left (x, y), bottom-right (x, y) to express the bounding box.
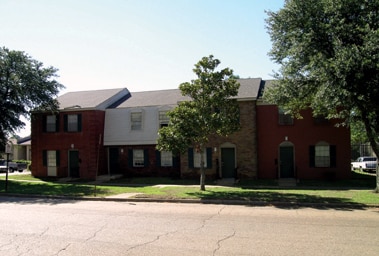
top-left (0, 172), bottom-right (379, 207)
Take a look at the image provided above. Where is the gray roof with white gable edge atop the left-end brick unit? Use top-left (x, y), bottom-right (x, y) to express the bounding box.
top-left (57, 88), bottom-right (130, 110)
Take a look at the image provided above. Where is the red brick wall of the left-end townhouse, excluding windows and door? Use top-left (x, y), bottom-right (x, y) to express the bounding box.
top-left (32, 110), bottom-right (107, 178)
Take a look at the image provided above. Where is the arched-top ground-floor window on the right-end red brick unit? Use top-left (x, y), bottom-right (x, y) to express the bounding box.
top-left (309, 142), bottom-right (336, 167)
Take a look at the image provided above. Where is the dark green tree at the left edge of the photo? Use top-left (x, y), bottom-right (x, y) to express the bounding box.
top-left (0, 47), bottom-right (63, 148)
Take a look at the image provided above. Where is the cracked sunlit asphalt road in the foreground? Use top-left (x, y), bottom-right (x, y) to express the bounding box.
top-left (0, 197), bottom-right (379, 256)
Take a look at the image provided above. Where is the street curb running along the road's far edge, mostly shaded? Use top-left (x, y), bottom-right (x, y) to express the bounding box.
top-left (0, 193), bottom-right (379, 209)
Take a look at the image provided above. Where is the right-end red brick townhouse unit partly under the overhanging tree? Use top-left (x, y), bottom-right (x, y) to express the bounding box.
top-left (257, 81), bottom-right (351, 179)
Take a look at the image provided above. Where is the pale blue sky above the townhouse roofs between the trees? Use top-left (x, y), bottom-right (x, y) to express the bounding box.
top-left (0, 0), bottom-right (284, 94)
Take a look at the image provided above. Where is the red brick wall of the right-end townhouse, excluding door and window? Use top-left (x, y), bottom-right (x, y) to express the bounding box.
top-left (257, 105), bottom-right (351, 179)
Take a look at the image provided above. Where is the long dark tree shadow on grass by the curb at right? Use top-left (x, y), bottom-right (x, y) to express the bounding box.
top-left (187, 190), bottom-right (367, 210)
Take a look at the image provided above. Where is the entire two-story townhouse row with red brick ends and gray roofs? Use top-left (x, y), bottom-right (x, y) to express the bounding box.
top-left (32, 78), bottom-right (350, 179)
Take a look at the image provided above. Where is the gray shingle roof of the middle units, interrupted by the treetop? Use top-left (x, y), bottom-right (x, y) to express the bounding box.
top-left (118, 78), bottom-right (262, 108)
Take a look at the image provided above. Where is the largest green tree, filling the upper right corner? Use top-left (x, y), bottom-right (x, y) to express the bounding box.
top-left (265, 0), bottom-right (379, 190)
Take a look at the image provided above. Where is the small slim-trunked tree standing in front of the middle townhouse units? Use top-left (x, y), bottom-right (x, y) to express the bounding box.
top-left (157, 55), bottom-right (239, 190)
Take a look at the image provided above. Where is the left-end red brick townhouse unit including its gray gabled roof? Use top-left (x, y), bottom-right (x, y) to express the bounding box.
top-left (31, 88), bottom-right (130, 178)
